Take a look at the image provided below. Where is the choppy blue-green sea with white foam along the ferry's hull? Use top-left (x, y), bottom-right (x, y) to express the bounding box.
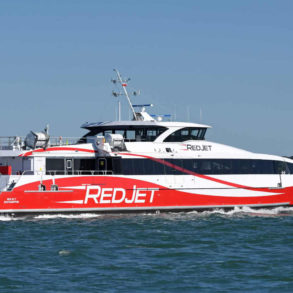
top-left (0, 208), bottom-right (293, 293)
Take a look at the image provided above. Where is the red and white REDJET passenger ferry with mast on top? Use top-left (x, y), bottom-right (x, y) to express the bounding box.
top-left (0, 69), bottom-right (293, 215)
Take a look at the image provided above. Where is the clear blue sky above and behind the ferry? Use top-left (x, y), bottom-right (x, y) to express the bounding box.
top-left (0, 0), bottom-right (293, 155)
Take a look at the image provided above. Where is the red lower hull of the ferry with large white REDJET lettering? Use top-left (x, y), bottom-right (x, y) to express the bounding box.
top-left (0, 176), bottom-right (293, 213)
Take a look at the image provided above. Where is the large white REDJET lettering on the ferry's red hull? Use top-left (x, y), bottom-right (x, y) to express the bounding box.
top-left (83, 185), bottom-right (159, 204)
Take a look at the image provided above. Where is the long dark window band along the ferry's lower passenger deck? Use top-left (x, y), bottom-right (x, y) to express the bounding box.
top-left (46, 157), bottom-right (293, 175)
